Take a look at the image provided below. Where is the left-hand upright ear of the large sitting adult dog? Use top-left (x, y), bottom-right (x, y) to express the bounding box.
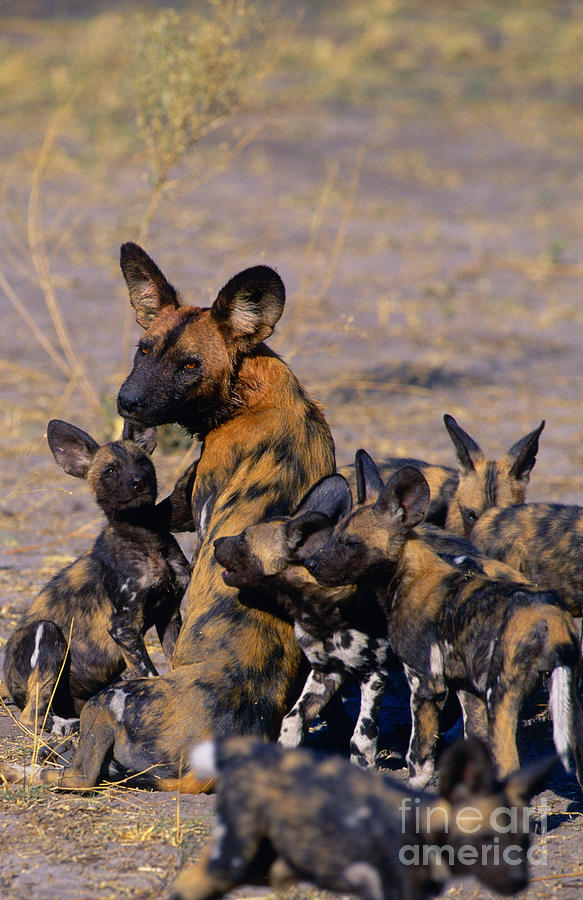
top-left (119, 241), bottom-right (180, 328)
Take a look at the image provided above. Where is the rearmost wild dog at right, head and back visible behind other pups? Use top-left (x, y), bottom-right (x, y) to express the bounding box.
top-left (339, 414), bottom-right (545, 536)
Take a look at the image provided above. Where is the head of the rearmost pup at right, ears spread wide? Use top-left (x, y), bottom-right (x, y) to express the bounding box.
top-left (443, 415), bottom-right (545, 537)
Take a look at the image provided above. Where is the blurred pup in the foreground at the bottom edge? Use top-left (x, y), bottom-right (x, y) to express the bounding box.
top-left (171, 738), bottom-right (554, 900)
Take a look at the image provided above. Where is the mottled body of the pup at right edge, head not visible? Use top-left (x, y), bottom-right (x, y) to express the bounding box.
top-left (472, 503), bottom-right (583, 617)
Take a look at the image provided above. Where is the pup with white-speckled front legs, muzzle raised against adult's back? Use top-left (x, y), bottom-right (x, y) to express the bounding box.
top-left (215, 464), bottom-right (480, 766)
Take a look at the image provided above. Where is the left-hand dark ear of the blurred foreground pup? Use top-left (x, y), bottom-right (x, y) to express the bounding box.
top-left (439, 738), bottom-right (497, 803)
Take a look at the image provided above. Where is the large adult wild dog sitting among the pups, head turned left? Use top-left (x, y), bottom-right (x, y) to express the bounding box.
top-left (4, 244), bottom-right (335, 792)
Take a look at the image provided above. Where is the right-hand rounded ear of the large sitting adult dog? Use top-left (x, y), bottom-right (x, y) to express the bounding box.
top-left (211, 266), bottom-right (285, 352)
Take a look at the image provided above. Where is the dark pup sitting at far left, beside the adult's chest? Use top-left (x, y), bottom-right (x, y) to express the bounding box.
top-left (5, 419), bottom-right (190, 729)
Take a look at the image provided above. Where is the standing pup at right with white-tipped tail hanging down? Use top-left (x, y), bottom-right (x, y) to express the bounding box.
top-left (305, 460), bottom-right (583, 786)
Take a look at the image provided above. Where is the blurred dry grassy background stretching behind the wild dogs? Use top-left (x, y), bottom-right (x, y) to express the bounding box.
top-left (0, 0), bottom-right (583, 560)
